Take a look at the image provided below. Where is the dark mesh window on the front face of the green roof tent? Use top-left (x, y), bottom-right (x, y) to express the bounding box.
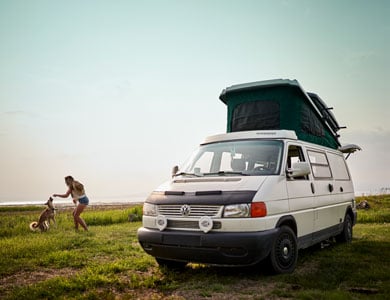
top-left (231, 101), bottom-right (280, 131)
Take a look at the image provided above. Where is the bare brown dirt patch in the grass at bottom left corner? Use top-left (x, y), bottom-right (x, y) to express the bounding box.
top-left (0, 268), bottom-right (77, 293)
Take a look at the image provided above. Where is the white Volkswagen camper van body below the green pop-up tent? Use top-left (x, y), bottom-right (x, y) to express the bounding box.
top-left (138, 81), bottom-right (358, 273)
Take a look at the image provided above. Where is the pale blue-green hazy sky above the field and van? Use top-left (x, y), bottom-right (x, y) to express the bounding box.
top-left (0, 0), bottom-right (390, 203)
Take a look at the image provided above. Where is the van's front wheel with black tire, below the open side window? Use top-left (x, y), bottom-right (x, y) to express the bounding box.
top-left (269, 226), bottom-right (298, 274)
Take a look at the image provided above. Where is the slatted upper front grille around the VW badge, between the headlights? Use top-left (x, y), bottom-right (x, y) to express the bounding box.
top-left (158, 204), bottom-right (223, 217)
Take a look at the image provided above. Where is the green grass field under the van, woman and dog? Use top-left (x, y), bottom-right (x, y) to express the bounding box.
top-left (0, 196), bottom-right (390, 299)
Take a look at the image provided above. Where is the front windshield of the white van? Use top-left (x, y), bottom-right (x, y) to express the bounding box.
top-left (177, 140), bottom-right (283, 177)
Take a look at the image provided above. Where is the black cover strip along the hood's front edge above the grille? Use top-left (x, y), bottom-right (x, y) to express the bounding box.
top-left (145, 191), bottom-right (257, 205)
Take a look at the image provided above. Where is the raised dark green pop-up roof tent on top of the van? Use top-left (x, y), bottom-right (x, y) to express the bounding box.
top-left (219, 79), bottom-right (341, 149)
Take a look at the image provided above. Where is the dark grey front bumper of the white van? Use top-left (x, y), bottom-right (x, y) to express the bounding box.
top-left (138, 227), bottom-right (277, 265)
